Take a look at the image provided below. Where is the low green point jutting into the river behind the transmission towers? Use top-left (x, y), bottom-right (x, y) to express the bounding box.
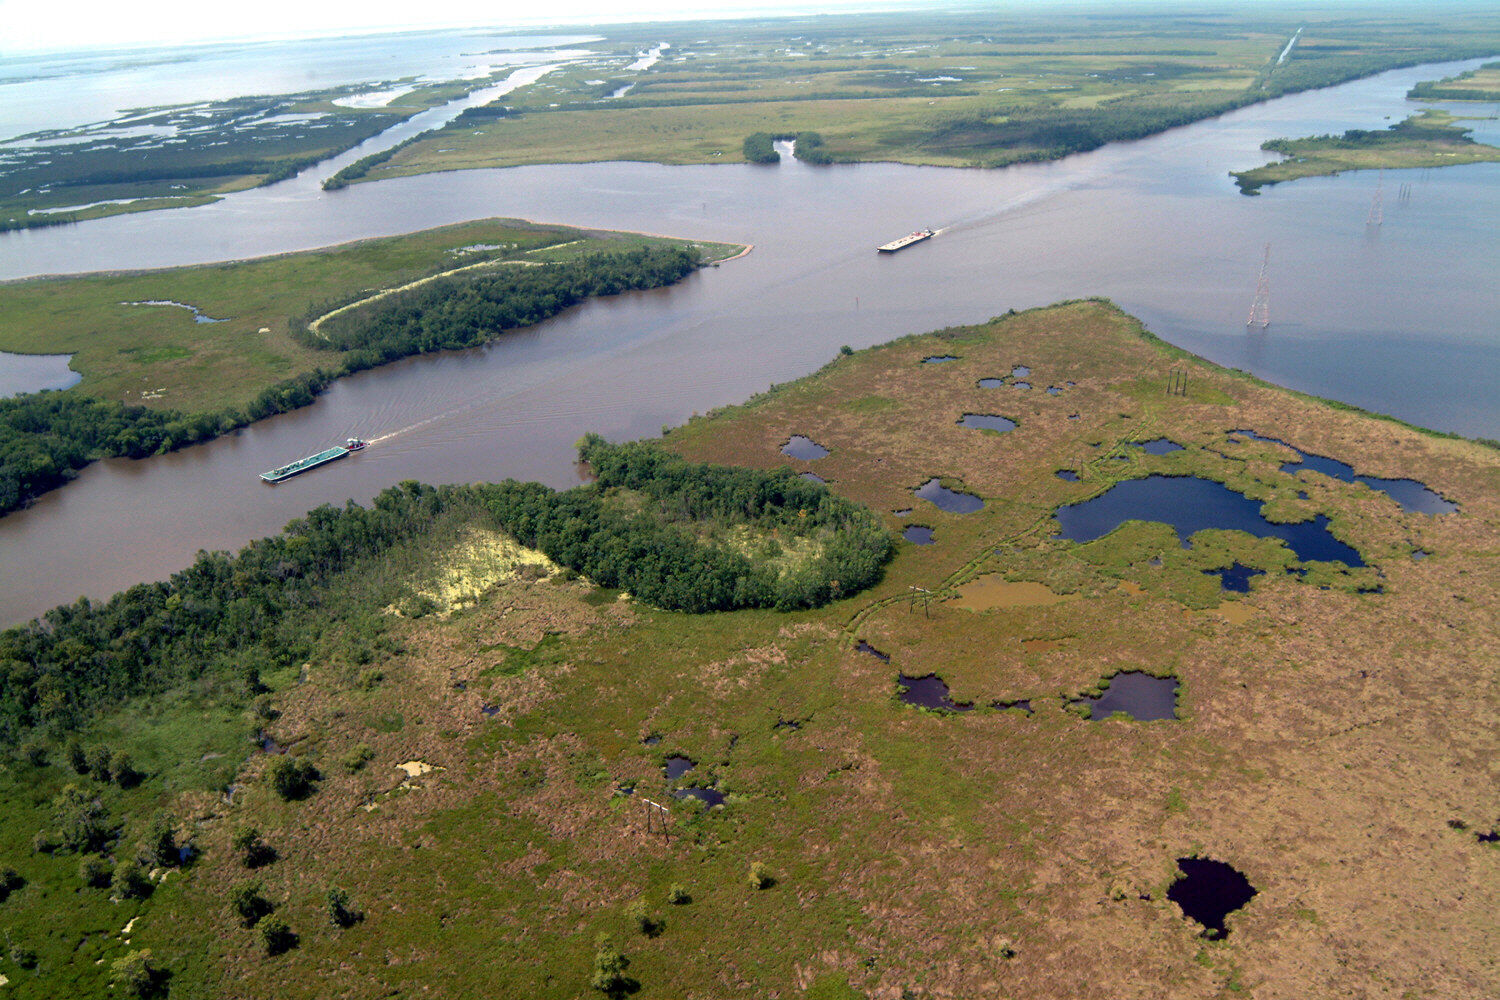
top-left (1232, 111), bottom-right (1500, 195)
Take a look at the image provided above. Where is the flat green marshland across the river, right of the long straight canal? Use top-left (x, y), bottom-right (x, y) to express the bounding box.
top-left (365, 6), bottom-right (1500, 180)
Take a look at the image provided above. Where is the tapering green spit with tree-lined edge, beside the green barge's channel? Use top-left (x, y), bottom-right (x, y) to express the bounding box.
top-left (0, 220), bottom-right (738, 513)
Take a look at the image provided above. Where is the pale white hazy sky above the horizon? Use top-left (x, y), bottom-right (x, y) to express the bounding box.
top-left (0, 0), bottom-right (953, 55)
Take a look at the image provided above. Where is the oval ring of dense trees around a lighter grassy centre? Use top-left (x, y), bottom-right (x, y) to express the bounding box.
top-left (480, 435), bottom-right (891, 613)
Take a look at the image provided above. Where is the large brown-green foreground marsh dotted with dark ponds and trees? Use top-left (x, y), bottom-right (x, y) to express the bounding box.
top-left (0, 300), bottom-right (1500, 1000)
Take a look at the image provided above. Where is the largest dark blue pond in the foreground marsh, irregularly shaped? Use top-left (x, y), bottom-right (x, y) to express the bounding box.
top-left (1058, 475), bottom-right (1365, 567)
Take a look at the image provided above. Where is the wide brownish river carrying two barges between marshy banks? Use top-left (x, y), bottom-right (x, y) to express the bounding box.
top-left (0, 60), bottom-right (1500, 622)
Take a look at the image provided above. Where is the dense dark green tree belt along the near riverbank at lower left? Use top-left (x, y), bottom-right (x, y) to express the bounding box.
top-left (0, 483), bottom-right (467, 745)
